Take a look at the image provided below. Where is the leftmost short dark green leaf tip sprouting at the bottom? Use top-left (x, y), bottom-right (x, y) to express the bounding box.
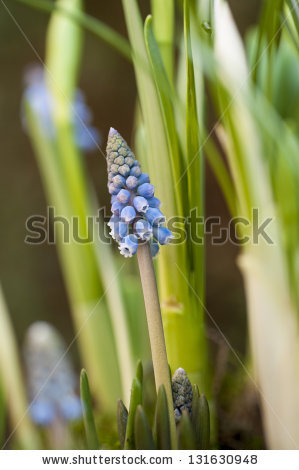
top-left (80, 369), bottom-right (100, 450)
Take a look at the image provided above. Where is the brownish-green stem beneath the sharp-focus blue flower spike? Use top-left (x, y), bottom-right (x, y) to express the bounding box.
top-left (137, 243), bottom-right (177, 449)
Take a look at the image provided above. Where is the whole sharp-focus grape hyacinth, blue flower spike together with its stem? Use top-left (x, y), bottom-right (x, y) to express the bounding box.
top-left (107, 128), bottom-right (177, 449)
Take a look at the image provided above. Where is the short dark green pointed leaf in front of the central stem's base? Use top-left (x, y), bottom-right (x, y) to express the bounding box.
top-left (154, 385), bottom-right (171, 450)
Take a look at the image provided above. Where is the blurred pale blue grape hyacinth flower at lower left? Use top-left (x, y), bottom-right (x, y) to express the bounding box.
top-left (24, 322), bottom-right (82, 426)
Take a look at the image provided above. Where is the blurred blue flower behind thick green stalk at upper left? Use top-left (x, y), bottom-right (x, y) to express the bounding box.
top-left (21, 65), bottom-right (100, 152)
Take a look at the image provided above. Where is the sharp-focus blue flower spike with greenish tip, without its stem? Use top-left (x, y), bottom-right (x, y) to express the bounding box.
top-left (106, 127), bottom-right (173, 258)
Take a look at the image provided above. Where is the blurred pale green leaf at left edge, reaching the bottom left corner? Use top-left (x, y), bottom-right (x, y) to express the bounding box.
top-left (0, 286), bottom-right (40, 450)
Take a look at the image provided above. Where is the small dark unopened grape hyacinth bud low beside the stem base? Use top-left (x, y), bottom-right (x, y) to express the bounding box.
top-left (172, 367), bottom-right (193, 423)
